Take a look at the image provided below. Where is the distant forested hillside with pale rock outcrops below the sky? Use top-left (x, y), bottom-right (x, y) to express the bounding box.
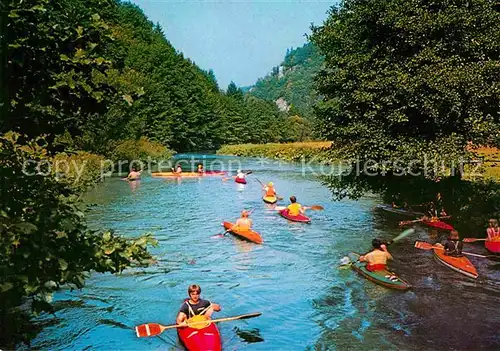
top-left (249, 43), bottom-right (323, 118)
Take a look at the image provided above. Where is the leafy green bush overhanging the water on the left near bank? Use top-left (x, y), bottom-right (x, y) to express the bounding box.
top-left (0, 136), bottom-right (155, 349)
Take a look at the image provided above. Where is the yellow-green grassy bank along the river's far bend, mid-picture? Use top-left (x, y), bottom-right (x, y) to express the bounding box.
top-left (217, 141), bottom-right (332, 162)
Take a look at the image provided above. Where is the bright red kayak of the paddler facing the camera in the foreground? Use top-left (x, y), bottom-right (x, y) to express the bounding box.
top-left (177, 315), bottom-right (222, 351)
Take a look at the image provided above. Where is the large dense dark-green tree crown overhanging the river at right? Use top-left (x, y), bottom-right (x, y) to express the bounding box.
top-left (312, 0), bottom-right (500, 167)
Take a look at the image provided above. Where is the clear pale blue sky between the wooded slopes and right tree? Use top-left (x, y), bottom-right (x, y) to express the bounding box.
top-left (132, 0), bottom-right (335, 89)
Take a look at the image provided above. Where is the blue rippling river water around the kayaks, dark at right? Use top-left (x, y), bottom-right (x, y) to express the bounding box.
top-left (32, 156), bottom-right (500, 351)
